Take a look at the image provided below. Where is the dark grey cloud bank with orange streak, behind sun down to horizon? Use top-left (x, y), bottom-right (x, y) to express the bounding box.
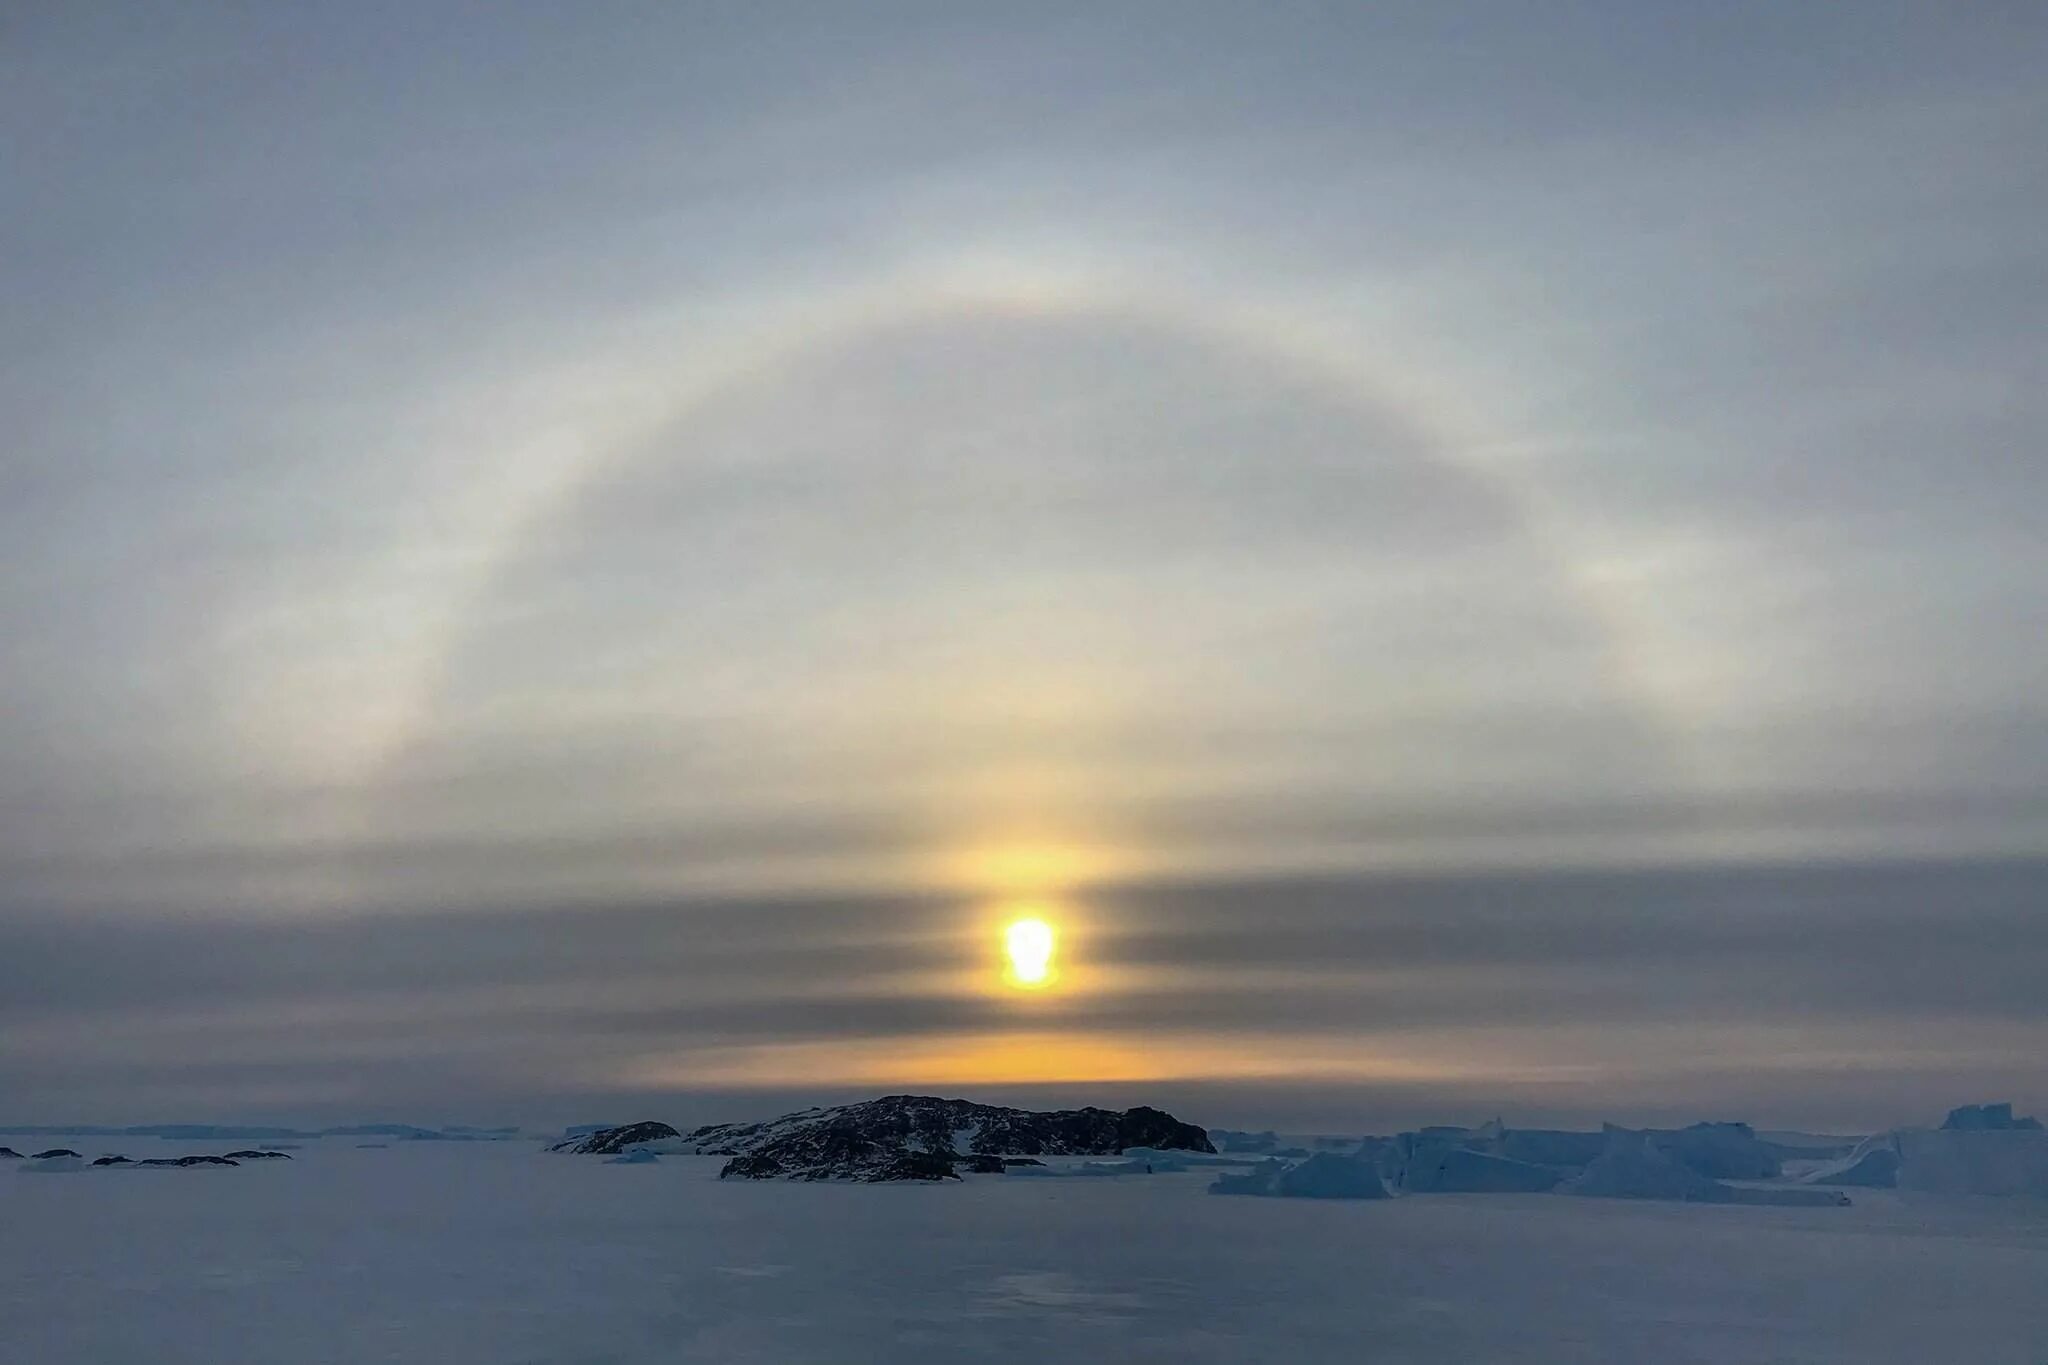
top-left (0, 864), bottom-right (2048, 1121)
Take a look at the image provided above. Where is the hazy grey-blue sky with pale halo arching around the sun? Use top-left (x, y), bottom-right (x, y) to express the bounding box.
top-left (0, 0), bottom-right (2048, 1130)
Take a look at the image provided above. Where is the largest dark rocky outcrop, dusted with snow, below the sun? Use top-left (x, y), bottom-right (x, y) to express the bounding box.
top-left (700, 1095), bottom-right (1214, 1181)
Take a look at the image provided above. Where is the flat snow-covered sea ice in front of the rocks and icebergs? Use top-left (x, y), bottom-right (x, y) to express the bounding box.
top-left (0, 1138), bottom-right (2048, 1365)
